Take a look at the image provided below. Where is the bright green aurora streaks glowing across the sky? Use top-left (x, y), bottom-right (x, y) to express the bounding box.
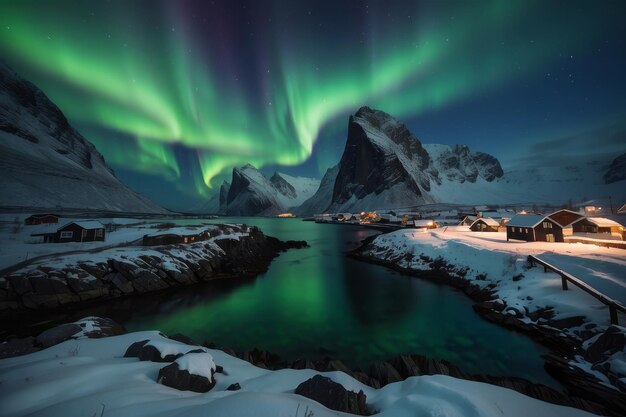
top-left (0, 1), bottom-right (618, 202)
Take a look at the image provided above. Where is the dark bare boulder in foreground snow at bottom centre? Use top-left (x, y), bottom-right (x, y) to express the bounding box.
top-left (295, 375), bottom-right (370, 416)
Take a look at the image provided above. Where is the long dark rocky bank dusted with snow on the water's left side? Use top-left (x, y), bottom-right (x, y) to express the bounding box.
top-left (0, 225), bottom-right (306, 308)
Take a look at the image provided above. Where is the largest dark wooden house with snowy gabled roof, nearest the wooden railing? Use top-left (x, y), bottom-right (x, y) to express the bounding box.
top-left (506, 214), bottom-right (563, 242)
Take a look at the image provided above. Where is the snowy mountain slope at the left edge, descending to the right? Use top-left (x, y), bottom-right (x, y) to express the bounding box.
top-left (0, 63), bottom-right (167, 213)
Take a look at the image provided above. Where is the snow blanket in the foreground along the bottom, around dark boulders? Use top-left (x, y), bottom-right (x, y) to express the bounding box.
top-left (0, 331), bottom-right (591, 417)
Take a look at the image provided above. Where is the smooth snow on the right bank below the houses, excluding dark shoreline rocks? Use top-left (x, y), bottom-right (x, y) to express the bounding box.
top-left (366, 226), bottom-right (626, 325)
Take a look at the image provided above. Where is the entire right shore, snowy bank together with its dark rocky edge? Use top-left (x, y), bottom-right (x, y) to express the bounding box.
top-left (349, 227), bottom-right (626, 414)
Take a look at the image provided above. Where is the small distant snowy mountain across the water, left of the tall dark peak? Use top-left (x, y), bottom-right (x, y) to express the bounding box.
top-left (218, 164), bottom-right (320, 216)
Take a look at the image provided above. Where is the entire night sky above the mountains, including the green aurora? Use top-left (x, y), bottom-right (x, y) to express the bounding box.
top-left (0, 0), bottom-right (626, 209)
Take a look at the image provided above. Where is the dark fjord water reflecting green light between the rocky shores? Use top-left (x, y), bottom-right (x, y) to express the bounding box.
top-left (119, 218), bottom-right (554, 385)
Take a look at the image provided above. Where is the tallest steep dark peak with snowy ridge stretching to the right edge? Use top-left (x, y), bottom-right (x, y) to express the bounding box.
top-left (294, 107), bottom-right (626, 215)
